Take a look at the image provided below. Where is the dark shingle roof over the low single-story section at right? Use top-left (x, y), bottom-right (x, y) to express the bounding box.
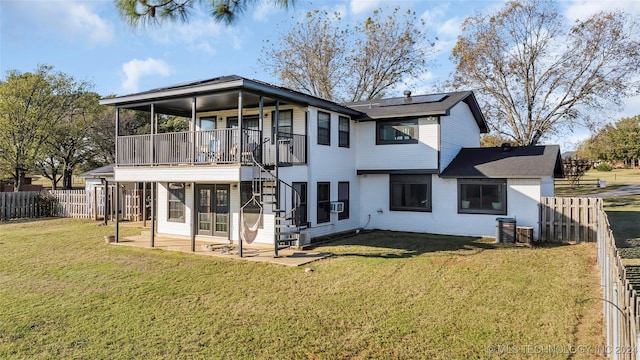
top-left (440, 145), bottom-right (563, 178)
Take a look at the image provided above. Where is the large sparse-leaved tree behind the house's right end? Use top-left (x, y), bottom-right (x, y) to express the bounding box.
top-left (453, 0), bottom-right (640, 145)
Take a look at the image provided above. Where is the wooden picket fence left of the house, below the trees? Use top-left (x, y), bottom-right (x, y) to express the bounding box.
top-left (0, 187), bottom-right (143, 221)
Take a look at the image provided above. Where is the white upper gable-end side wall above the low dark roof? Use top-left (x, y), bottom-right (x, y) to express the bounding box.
top-left (440, 102), bottom-right (480, 171)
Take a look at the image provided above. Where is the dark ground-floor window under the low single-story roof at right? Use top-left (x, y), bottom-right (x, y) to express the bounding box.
top-left (458, 179), bottom-right (507, 215)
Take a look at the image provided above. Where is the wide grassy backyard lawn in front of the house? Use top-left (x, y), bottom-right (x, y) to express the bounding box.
top-left (0, 219), bottom-right (603, 359)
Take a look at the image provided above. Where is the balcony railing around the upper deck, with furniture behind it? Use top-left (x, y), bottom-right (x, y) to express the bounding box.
top-left (116, 128), bottom-right (307, 166)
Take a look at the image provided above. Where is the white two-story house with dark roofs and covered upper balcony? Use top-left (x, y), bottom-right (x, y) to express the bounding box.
top-left (101, 76), bottom-right (562, 255)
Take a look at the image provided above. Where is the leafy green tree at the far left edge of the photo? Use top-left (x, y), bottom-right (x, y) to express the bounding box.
top-left (0, 66), bottom-right (90, 191)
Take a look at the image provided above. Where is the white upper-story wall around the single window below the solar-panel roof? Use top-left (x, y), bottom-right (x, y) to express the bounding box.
top-left (356, 118), bottom-right (439, 170)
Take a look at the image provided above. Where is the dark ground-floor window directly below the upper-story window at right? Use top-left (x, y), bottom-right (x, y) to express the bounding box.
top-left (389, 174), bottom-right (431, 211)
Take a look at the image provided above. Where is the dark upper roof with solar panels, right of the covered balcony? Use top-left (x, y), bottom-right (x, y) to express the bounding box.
top-left (344, 91), bottom-right (488, 133)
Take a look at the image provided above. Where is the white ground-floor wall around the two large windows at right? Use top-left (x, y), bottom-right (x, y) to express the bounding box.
top-left (360, 175), bottom-right (540, 238)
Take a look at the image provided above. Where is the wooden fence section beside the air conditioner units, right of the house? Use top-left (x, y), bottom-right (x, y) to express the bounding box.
top-left (538, 197), bottom-right (602, 243)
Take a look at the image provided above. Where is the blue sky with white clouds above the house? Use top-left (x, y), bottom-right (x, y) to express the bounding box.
top-left (0, 0), bottom-right (640, 148)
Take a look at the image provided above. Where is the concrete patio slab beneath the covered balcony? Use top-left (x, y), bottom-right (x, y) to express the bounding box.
top-left (110, 235), bottom-right (331, 266)
